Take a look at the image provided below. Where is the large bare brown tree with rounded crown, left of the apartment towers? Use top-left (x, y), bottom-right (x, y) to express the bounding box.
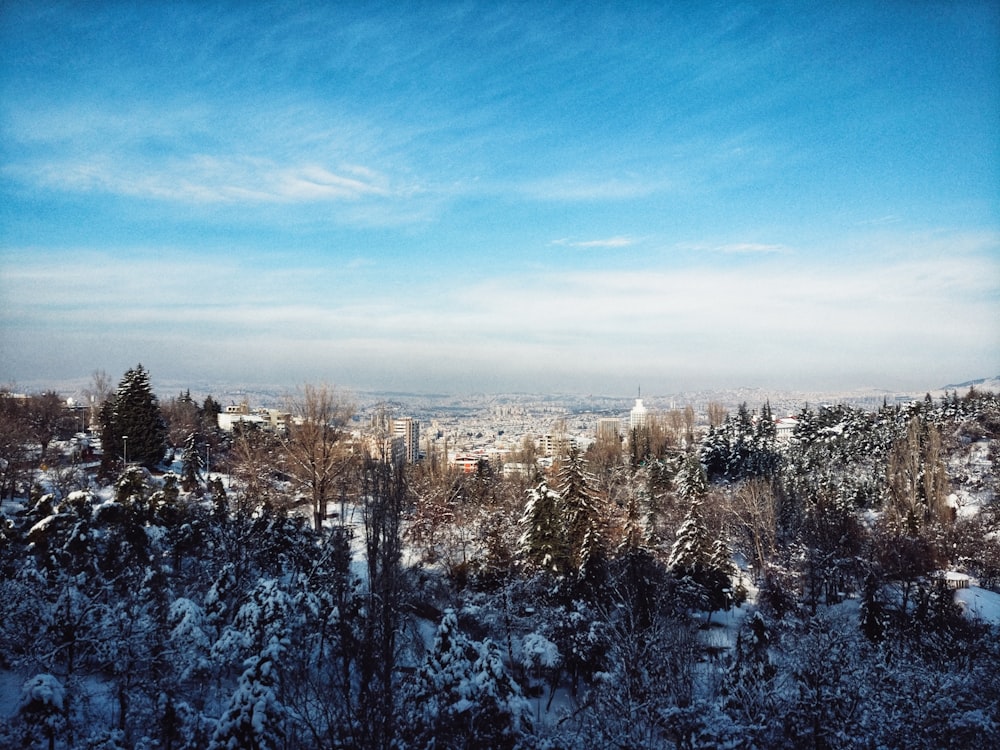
top-left (282, 385), bottom-right (353, 531)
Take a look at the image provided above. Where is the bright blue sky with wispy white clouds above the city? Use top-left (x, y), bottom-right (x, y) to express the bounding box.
top-left (0, 0), bottom-right (1000, 395)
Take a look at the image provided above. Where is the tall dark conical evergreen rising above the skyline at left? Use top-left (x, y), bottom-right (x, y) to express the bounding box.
top-left (100, 364), bottom-right (167, 468)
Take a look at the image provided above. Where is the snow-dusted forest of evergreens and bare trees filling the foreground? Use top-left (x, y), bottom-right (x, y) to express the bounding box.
top-left (0, 365), bottom-right (1000, 750)
